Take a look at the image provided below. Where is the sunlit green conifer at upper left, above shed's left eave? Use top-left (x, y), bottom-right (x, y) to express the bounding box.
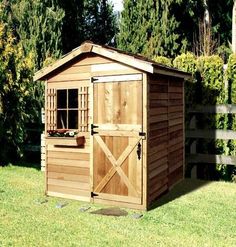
top-left (10, 0), bottom-right (64, 70)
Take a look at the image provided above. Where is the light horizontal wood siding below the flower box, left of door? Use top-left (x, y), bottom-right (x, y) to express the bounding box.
top-left (46, 135), bottom-right (90, 201)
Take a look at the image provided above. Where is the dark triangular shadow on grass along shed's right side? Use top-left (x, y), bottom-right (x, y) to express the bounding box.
top-left (149, 179), bottom-right (211, 211)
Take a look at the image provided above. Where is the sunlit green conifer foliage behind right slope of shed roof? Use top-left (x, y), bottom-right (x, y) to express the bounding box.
top-left (117, 0), bottom-right (183, 58)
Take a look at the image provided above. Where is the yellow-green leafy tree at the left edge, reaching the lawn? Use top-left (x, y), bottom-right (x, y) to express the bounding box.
top-left (0, 21), bottom-right (34, 165)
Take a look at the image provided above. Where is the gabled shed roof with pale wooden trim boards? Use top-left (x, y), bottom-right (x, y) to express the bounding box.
top-left (34, 41), bottom-right (191, 81)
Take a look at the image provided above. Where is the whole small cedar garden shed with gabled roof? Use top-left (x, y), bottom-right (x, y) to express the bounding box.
top-left (34, 42), bottom-right (189, 209)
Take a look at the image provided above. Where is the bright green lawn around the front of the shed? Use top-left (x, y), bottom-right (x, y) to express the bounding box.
top-left (0, 166), bottom-right (236, 247)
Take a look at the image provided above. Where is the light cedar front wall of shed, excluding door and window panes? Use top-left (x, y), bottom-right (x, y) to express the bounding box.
top-left (46, 54), bottom-right (142, 201)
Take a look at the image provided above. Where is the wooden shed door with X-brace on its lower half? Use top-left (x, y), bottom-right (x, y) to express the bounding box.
top-left (92, 74), bottom-right (143, 204)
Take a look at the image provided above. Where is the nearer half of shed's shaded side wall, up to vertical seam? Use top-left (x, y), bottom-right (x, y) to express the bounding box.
top-left (147, 75), bottom-right (168, 205)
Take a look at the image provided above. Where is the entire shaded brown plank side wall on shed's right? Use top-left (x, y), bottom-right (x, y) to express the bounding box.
top-left (147, 75), bottom-right (184, 205)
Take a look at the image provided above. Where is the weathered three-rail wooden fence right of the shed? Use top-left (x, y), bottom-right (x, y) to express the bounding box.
top-left (185, 105), bottom-right (236, 177)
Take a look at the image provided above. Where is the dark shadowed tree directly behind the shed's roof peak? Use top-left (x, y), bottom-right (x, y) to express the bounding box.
top-left (58, 0), bottom-right (117, 53)
